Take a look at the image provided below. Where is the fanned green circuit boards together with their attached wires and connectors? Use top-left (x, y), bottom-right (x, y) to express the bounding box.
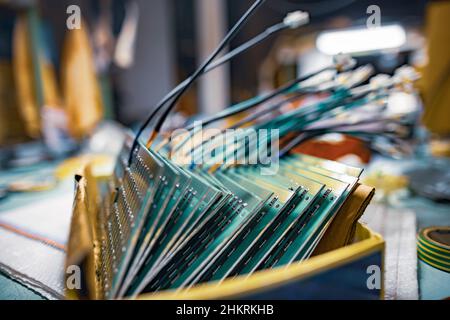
top-left (96, 0), bottom-right (422, 299)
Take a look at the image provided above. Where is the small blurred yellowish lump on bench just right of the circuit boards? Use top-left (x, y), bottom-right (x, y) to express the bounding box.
top-left (362, 171), bottom-right (409, 196)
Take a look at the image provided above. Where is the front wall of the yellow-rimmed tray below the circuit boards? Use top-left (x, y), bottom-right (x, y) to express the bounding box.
top-left (143, 224), bottom-right (384, 300)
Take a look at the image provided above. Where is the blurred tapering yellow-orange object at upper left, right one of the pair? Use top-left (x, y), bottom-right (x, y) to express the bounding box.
top-left (61, 23), bottom-right (103, 139)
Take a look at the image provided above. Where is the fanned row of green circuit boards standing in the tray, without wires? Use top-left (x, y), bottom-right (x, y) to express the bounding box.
top-left (97, 131), bottom-right (361, 299)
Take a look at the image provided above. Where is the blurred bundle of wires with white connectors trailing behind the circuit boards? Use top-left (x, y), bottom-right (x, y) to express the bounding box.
top-left (167, 60), bottom-right (418, 168)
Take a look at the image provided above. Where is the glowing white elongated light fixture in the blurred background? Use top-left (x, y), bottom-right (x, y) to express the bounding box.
top-left (316, 25), bottom-right (406, 55)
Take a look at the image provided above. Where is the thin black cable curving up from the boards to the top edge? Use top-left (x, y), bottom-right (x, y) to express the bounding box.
top-left (128, 0), bottom-right (266, 165)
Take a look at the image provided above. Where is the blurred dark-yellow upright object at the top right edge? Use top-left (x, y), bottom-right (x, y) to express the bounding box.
top-left (421, 1), bottom-right (450, 135)
